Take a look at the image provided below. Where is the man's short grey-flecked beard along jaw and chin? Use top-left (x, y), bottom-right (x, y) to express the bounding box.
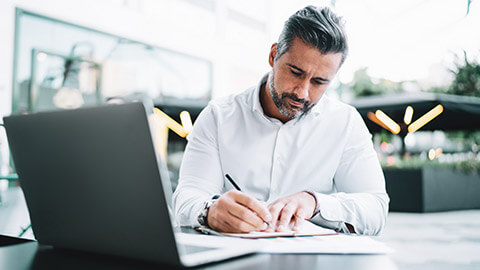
top-left (268, 69), bottom-right (315, 119)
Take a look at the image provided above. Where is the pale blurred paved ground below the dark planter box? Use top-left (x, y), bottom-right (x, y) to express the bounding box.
top-left (378, 210), bottom-right (480, 270)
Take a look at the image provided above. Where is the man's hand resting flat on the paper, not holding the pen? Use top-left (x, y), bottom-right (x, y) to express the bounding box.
top-left (268, 191), bottom-right (316, 232)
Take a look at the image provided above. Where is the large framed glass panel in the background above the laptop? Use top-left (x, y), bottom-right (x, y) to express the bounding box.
top-left (13, 9), bottom-right (212, 113)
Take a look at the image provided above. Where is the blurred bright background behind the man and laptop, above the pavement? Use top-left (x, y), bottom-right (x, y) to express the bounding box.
top-left (0, 0), bottom-right (480, 268)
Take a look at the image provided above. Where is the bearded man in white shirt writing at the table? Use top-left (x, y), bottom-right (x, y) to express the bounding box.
top-left (173, 6), bottom-right (389, 235)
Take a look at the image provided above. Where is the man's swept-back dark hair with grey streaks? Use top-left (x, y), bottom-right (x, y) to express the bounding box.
top-left (275, 6), bottom-right (348, 65)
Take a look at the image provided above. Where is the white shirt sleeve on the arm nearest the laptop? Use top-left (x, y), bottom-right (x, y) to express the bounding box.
top-left (173, 105), bottom-right (224, 226)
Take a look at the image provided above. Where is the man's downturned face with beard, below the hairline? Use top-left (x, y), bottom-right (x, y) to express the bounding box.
top-left (268, 38), bottom-right (342, 119)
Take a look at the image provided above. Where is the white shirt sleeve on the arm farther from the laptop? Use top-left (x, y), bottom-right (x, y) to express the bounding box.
top-left (312, 110), bottom-right (389, 235)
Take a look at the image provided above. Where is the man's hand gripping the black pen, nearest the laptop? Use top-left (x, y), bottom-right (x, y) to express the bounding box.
top-left (207, 190), bottom-right (272, 233)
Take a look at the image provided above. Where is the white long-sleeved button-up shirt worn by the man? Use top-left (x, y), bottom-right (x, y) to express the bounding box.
top-left (173, 77), bottom-right (389, 235)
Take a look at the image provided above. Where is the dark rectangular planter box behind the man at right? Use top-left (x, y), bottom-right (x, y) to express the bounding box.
top-left (383, 168), bottom-right (480, 212)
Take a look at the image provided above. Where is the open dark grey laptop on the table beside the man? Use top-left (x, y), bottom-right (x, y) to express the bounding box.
top-left (4, 103), bottom-right (258, 267)
